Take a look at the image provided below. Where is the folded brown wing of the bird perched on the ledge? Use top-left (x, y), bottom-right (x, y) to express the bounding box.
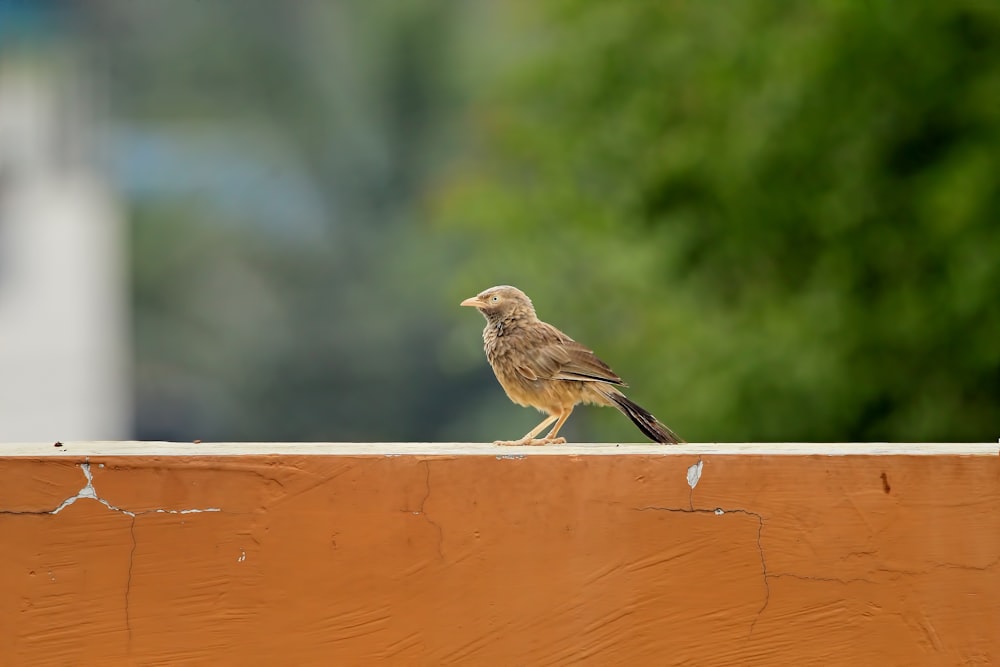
top-left (517, 327), bottom-right (625, 385)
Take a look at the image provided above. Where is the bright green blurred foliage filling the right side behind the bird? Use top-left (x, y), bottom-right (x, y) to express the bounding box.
top-left (437, 0), bottom-right (1000, 441)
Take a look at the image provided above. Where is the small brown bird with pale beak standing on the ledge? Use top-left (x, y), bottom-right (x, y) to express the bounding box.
top-left (461, 285), bottom-right (682, 445)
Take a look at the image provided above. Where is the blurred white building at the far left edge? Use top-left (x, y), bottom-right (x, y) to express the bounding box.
top-left (0, 58), bottom-right (132, 447)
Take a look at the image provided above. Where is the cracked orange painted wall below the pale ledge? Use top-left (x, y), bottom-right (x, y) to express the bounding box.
top-left (0, 445), bottom-right (1000, 665)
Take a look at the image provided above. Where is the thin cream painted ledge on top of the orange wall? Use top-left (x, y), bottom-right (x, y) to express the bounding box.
top-left (0, 440), bottom-right (1000, 458)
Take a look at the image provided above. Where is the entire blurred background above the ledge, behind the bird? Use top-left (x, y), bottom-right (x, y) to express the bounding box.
top-left (0, 0), bottom-right (1000, 442)
